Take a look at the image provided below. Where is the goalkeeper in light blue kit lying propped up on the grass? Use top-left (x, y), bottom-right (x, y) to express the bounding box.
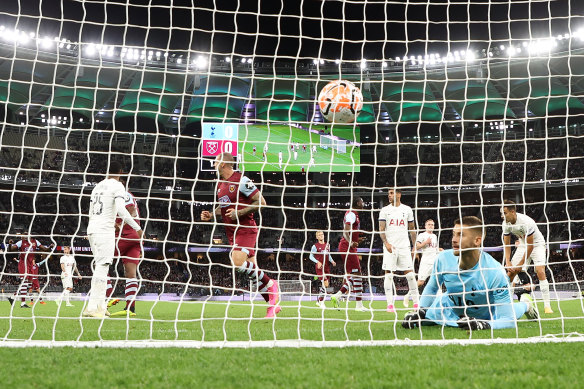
top-left (402, 216), bottom-right (538, 330)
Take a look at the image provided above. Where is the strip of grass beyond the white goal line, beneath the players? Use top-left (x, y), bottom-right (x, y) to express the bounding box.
top-left (0, 297), bottom-right (584, 341)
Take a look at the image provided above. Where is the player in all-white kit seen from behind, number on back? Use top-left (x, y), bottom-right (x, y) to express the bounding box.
top-left (83, 161), bottom-right (143, 317)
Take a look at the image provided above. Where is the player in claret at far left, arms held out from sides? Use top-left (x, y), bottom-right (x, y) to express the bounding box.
top-left (8, 236), bottom-right (55, 308)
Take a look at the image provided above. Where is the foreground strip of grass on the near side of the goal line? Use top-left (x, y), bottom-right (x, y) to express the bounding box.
top-left (0, 344), bottom-right (584, 388)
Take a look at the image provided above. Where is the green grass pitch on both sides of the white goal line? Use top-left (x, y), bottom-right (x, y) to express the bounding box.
top-left (0, 300), bottom-right (584, 388)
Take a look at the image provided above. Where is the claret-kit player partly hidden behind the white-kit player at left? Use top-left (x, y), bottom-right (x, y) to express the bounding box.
top-left (108, 192), bottom-right (142, 317)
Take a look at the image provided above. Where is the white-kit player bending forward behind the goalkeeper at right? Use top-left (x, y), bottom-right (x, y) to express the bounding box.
top-left (501, 200), bottom-right (554, 313)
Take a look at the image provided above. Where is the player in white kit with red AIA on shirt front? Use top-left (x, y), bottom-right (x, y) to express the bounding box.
top-left (379, 188), bottom-right (419, 312)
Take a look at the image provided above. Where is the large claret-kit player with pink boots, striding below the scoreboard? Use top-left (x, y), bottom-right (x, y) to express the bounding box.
top-left (201, 153), bottom-right (281, 317)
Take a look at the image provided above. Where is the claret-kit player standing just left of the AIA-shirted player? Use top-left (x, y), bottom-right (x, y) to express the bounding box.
top-left (331, 197), bottom-right (367, 312)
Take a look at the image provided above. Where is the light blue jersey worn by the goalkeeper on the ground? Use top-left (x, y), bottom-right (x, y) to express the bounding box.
top-left (420, 250), bottom-right (524, 329)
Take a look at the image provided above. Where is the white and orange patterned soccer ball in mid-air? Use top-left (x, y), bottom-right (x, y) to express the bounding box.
top-left (318, 80), bottom-right (363, 123)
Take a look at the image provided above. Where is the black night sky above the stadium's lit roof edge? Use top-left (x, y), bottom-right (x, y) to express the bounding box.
top-left (0, 0), bottom-right (584, 59)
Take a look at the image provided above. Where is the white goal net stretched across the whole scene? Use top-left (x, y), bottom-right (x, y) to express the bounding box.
top-left (0, 0), bottom-right (584, 347)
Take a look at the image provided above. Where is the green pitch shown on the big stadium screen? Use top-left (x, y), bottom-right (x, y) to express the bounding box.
top-left (239, 124), bottom-right (361, 172)
